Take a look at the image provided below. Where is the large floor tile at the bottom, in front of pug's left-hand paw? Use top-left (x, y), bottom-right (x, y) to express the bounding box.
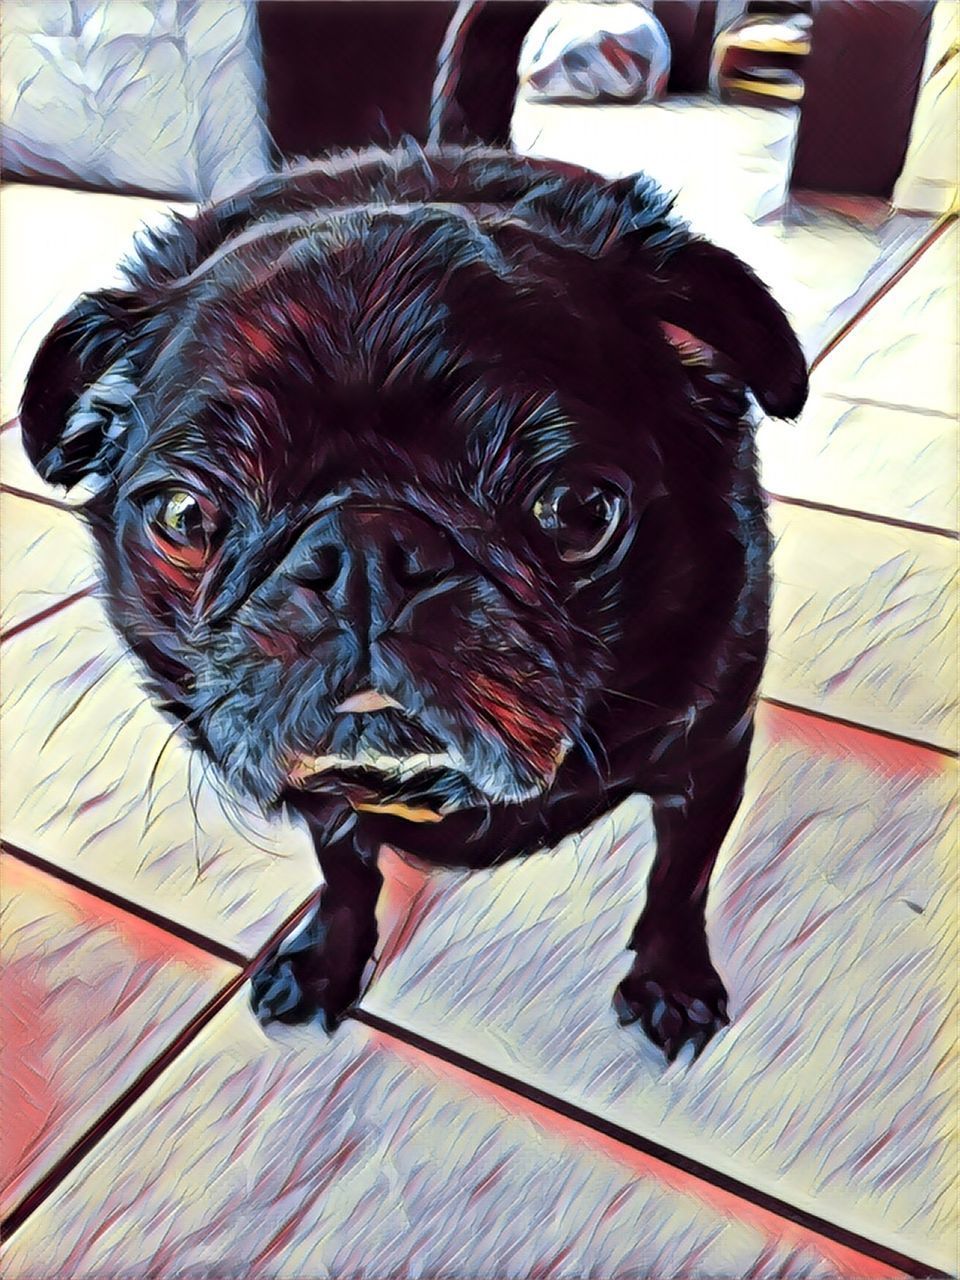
top-left (5, 997), bottom-right (896, 1280)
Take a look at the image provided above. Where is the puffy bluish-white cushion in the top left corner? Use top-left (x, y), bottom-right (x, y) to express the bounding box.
top-left (0, 0), bottom-right (268, 197)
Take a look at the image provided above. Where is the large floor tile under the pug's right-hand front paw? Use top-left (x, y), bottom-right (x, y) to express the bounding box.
top-left (364, 707), bottom-right (957, 1268)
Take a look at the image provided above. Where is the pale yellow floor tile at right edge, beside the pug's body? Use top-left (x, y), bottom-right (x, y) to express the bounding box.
top-left (762, 503), bottom-right (957, 749)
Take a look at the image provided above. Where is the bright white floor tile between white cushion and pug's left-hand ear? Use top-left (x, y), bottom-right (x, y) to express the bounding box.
top-left (0, 182), bottom-right (192, 422)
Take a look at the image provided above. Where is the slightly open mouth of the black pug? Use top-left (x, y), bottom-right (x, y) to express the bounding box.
top-left (284, 751), bottom-right (485, 823)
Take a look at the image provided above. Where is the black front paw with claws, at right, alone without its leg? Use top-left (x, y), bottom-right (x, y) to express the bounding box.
top-left (613, 960), bottom-right (730, 1062)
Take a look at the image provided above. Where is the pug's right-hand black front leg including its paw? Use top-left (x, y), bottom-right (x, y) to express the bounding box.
top-left (614, 726), bottom-right (753, 1061)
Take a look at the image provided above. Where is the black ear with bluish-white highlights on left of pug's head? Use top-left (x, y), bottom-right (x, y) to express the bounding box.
top-left (20, 289), bottom-right (154, 486)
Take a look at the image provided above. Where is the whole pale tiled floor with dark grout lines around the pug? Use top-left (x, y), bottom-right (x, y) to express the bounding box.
top-left (0, 113), bottom-right (960, 1280)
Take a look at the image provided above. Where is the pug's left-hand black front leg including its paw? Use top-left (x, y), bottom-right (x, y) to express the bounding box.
top-left (251, 826), bottom-right (383, 1032)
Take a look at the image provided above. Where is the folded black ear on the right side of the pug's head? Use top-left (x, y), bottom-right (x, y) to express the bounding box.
top-left (655, 239), bottom-right (806, 417)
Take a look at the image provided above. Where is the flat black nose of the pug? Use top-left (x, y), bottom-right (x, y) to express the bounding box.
top-left (296, 506), bottom-right (453, 616)
